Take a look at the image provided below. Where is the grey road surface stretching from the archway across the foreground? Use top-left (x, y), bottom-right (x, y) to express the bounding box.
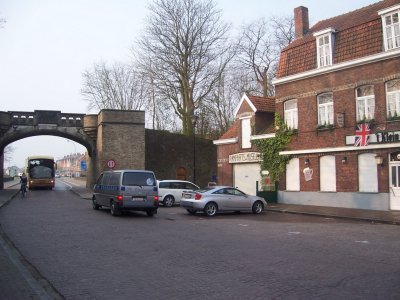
top-left (0, 182), bottom-right (400, 299)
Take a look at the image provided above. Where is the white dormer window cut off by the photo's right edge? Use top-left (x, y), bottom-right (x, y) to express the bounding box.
top-left (379, 5), bottom-right (400, 51)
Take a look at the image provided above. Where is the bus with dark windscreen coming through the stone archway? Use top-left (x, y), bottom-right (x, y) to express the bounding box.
top-left (25, 155), bottom-right (56, 190)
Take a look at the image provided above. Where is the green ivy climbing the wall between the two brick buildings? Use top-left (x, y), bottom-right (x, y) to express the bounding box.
top-left (254, 113), bottom-right (294, 182)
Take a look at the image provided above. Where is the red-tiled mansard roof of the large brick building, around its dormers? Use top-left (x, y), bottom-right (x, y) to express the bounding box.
top-left (276, 0), bottom-right (400, 78)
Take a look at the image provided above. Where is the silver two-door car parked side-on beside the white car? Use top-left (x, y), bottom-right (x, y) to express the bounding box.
top-left (181, 186), bottom-right (267, 217)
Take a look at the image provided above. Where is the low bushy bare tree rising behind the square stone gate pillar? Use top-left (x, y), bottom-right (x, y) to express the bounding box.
top-left (81, 62), bottom-right (147, 110)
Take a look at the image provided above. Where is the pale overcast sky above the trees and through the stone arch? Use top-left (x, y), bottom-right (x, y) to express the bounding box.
top-left (0, 0), bottom-right (378, 167)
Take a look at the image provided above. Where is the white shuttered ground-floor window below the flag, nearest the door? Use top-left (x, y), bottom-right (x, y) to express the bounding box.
top-left (358, 153), bottom-right (378, 193)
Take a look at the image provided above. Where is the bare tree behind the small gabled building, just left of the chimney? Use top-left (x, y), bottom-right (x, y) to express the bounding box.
top-left (238, 17), bottom-right (294, 97)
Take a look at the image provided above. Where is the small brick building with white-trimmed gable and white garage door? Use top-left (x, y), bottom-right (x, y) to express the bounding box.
top-left (214, 94), bottom-right (275, 195)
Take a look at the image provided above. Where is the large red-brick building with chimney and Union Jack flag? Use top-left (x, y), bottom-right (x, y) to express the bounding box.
top-left (274, 0), bottom-right (400, 210)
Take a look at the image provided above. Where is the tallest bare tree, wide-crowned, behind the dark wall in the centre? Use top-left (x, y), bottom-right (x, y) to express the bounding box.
top-left (135, 0), bottom-right (233, 134)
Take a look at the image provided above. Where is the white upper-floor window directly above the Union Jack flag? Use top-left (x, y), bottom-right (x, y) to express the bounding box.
top-left (356, 85), bottom-right (375, 121)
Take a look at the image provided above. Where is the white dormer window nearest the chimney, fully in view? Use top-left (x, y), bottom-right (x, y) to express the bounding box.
top-left (314, 28), bottom-right (335, 68)
